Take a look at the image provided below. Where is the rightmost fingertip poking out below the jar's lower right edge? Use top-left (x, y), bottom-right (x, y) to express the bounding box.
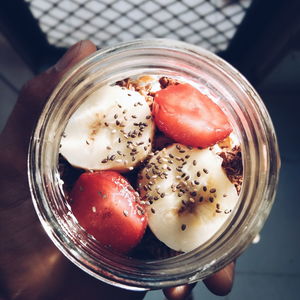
top-left (203, 262), bottom-right (235, 296)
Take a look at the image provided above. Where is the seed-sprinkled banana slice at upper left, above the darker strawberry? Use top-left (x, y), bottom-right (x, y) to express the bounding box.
top-left (60, 86), bottom-right (154, 171)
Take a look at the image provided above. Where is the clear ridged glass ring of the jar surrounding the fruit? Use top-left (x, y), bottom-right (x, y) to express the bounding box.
top-left (28, 39), bottom-right (280, 290)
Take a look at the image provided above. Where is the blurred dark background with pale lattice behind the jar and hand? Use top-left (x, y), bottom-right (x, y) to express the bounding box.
top-left (0, 0), bottom-right (300, 300)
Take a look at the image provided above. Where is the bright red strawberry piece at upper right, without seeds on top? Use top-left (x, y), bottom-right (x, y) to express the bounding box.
top-left (152, 83), bottom-right (232, 148)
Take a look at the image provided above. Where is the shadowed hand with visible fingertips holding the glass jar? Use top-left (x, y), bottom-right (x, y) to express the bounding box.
top-left (0, 41), bottom-right (234, 300)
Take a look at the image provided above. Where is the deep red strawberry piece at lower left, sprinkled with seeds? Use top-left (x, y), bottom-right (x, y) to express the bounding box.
top-left (70, 171), bottom-right (147, 253)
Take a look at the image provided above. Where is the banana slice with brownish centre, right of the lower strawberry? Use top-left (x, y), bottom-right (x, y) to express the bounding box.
top-left (139, 144), bottom-right (238, 252)
